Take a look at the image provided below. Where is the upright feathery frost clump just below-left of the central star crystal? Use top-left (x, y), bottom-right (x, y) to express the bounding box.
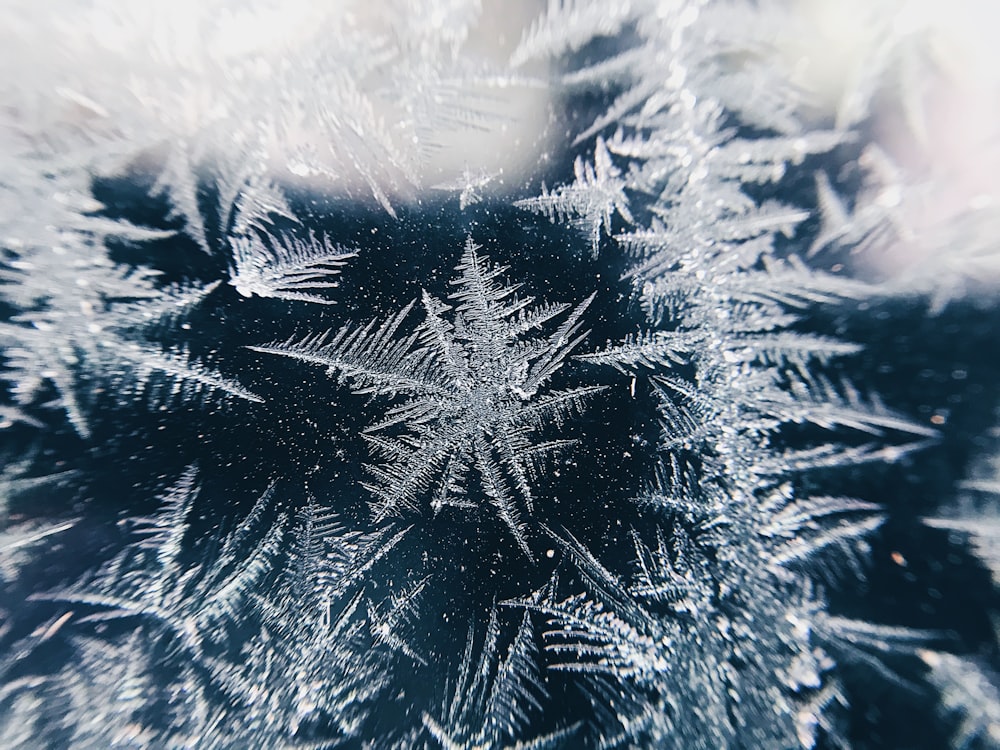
top-left (219, 502), bottom-right (406, 742)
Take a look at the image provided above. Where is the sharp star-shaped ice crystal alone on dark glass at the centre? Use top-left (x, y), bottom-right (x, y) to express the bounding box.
top-left (251, 238), bottom-right (601, 557)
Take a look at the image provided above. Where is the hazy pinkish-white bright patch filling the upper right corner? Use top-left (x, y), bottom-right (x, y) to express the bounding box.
top-left (783, 0), bottom-right (1000, 309)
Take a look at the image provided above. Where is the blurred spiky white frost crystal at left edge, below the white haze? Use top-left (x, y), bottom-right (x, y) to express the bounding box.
top-left (0, 194), bottom-right (260, 437)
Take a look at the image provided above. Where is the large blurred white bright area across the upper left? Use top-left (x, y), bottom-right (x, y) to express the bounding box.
top-left (0, 0), bottom-right (550, 212)
